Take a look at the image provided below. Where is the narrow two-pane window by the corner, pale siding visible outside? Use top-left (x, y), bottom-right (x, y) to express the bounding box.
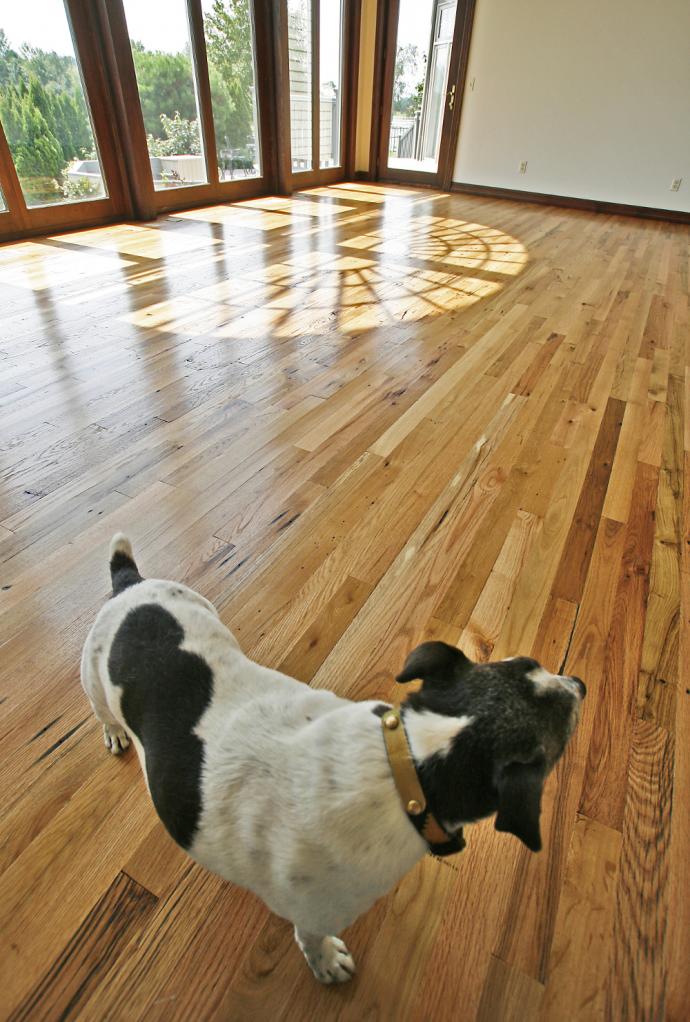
top-left (286, 0), bottom-right (347, 188)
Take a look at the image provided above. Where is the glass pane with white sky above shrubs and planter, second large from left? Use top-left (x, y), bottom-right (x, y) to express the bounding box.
top-left (124, 0), bottom-right (208, 191)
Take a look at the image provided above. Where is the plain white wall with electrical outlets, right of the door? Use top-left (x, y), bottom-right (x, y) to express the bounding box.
top-left (453, 0), bottom-right (690, 212)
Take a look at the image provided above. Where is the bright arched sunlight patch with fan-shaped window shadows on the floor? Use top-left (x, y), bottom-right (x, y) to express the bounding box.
top-left (160, 185), bottom-right (528, 347)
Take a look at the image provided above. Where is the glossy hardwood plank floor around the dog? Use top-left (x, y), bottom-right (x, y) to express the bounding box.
top-left (0, 184), bottom-right (690, 1022)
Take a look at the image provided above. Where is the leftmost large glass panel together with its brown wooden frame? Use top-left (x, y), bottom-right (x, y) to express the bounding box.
top-left (0, 0), bottom-right (122, 233)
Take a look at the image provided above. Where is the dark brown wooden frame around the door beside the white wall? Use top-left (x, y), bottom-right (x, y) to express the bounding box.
top-left (368, 0), bottom-right (475, 191)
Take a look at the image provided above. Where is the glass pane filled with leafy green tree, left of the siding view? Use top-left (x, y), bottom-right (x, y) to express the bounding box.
top-left (201, 0), bottom-right (261, 181)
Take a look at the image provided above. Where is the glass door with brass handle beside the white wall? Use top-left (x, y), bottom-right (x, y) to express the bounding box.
top-left (378, 0), bottom-right (471, 185)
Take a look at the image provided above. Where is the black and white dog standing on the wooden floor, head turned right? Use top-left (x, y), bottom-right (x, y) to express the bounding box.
top-left (82, 535), bottom-right (585, 983)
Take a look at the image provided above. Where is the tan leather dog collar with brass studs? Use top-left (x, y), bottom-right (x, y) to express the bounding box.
top-left (381, 708), bottom-right (465, 855)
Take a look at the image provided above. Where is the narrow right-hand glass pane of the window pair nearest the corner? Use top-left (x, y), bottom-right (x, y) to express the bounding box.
top-left (319, 0), bottom-right (342, 167)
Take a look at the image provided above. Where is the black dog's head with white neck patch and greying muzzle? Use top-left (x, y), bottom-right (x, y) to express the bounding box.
top-left (397, 642), bottom-right (587, 851)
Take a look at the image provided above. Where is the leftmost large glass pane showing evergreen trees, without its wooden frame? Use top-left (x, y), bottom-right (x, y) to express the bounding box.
top-left (0, 0), bottom-right (106, 206)
